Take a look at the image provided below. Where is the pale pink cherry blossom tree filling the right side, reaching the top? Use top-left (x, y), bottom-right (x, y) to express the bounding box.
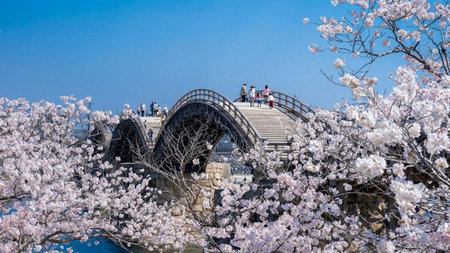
top-left (185, 0), bottom-right (450, 252)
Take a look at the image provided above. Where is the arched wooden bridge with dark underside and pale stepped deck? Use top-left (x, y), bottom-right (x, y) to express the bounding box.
top-left (107, 89), bottom-right (313, 170)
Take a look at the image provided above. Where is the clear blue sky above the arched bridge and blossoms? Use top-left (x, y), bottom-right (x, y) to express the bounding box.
top-left (0, 0), bottom-right (396, 113)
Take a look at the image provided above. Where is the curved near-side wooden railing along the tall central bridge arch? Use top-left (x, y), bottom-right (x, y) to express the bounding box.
top-left (160, 89), bottom-right (261, 143)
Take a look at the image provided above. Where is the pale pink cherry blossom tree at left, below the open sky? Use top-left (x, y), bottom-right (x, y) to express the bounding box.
top-left (0, 97), bottom-right (191, 252)
